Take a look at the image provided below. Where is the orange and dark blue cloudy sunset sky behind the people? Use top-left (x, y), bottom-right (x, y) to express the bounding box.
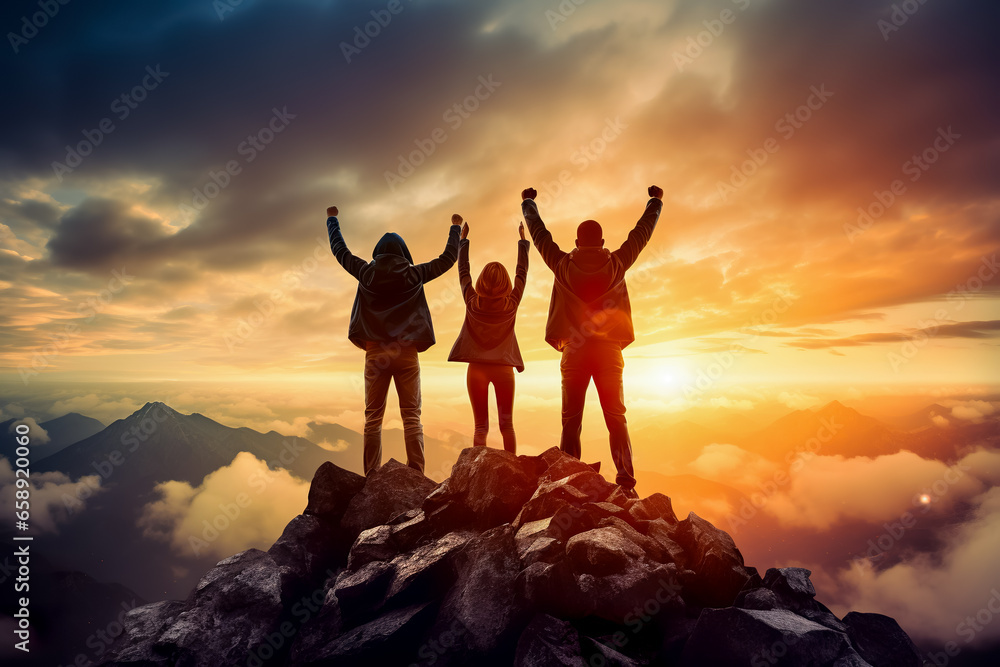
top-left (0, 0), bottom-right (1000, 656)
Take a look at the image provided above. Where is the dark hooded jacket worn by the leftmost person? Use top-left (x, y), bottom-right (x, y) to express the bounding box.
top-left (326, 217), bottom-right (459, 352)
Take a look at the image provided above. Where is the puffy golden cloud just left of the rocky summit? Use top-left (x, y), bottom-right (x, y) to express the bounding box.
top-left (138, 452), bottom-right (309, 557)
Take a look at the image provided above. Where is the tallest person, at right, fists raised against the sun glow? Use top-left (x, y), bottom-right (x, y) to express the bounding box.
top-left (521, 185), bottom-right (663, 497)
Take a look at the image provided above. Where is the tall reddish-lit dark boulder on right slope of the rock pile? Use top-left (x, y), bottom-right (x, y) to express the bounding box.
top-left (673, 512), bottom-right (750, 607)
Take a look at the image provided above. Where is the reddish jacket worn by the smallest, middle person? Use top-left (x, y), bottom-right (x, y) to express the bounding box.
top-left (448, 239), bottom-right (529, 373)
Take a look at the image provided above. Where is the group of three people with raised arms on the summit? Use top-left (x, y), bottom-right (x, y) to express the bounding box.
top-left (327, 185), bottom-right (663, 497)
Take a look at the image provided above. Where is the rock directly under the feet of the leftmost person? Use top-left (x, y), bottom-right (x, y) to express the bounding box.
top-left (340, 459), bottom-right (437, 542)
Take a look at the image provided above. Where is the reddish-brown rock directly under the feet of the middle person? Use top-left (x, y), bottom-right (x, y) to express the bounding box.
top-left (424, 447), bottom-right (539, 530)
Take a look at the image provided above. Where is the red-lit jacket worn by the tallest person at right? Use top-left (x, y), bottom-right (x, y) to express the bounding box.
top-left (521, 197), bottom-right (663, 351)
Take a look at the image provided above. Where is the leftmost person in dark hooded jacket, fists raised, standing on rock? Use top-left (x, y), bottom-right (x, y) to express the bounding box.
top-left (326, 206), bottom-right (460, 475)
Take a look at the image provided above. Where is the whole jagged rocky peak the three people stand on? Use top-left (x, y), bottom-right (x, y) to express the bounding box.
top-left (101, 447), bottom-right (920, 667)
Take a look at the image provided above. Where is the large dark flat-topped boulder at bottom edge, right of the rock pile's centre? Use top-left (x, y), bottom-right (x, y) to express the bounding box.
top-left (681, 607), bottom-right (866, 667)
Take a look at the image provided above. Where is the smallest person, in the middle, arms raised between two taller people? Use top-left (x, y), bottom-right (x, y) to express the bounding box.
top-left (448, 217), bottom-right (529, 453)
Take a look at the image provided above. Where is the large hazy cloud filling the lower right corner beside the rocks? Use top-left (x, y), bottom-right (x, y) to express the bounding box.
top-left (836, 488), bottom-right (1000, 647)
